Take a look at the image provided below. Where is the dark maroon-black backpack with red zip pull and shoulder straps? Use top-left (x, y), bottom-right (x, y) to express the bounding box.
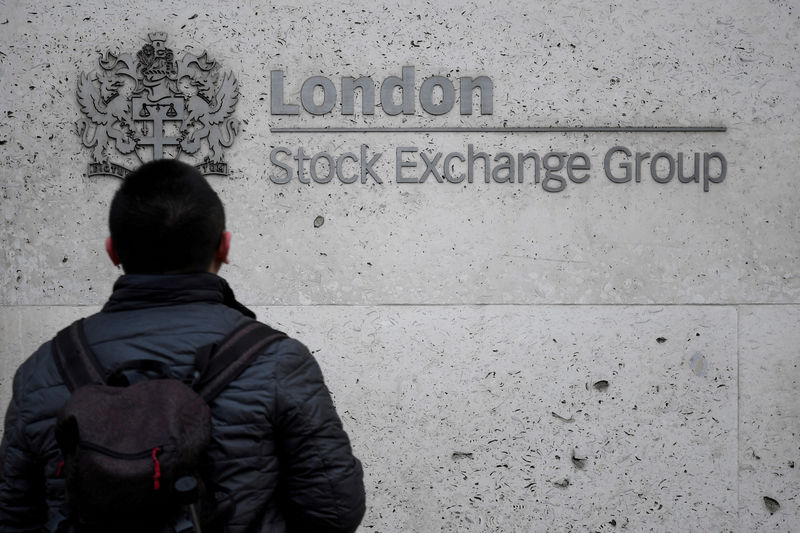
top-left (53, 320), bottom-right (286, 533)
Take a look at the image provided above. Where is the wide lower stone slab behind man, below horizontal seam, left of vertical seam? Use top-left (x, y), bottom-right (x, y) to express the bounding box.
top-left (0, 306), bottom-right (747, 532)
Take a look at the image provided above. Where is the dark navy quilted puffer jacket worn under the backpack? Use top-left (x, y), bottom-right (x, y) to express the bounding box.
top-left (0, 274), bottom-right (364, 533)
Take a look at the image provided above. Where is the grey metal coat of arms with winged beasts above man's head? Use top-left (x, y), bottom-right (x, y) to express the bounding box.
top-left (77, 33), bottom-right (239, 178)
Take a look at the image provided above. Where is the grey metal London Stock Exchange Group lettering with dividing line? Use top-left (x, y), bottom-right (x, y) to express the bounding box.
top-left (269, 65), bottom-right (728, 193)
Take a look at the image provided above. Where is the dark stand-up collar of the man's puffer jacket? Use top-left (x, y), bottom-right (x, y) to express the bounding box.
top-left (103, 272), bottom-right (256, 318)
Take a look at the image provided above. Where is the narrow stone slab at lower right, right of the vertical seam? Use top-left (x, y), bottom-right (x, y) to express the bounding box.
top-left (739, 306), bottom-right (800, 532)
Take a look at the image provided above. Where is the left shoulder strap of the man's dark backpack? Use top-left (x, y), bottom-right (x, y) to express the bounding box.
top-left (52, 319), bottom-right (106, 392)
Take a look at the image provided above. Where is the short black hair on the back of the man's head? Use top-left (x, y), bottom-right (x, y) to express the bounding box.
top-left (108, 159), bottom-right (225, 274)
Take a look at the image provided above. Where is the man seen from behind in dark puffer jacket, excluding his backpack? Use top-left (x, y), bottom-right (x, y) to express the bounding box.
top-left (0, 160), bottom-right (364, 533)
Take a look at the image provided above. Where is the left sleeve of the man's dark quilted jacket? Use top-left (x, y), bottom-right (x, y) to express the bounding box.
top-left (0, 372), bottom-right (47, 533)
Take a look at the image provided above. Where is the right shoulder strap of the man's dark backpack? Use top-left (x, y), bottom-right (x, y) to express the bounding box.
top-left (194, 321), bottom-right (287, 403)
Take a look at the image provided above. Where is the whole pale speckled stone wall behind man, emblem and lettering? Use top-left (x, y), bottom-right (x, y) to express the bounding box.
top-left (0, 0), bottom-right (800, 533)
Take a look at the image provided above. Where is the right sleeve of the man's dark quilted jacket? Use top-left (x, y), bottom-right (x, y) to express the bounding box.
top-left (276, 341), bottom-right (365, 533)
